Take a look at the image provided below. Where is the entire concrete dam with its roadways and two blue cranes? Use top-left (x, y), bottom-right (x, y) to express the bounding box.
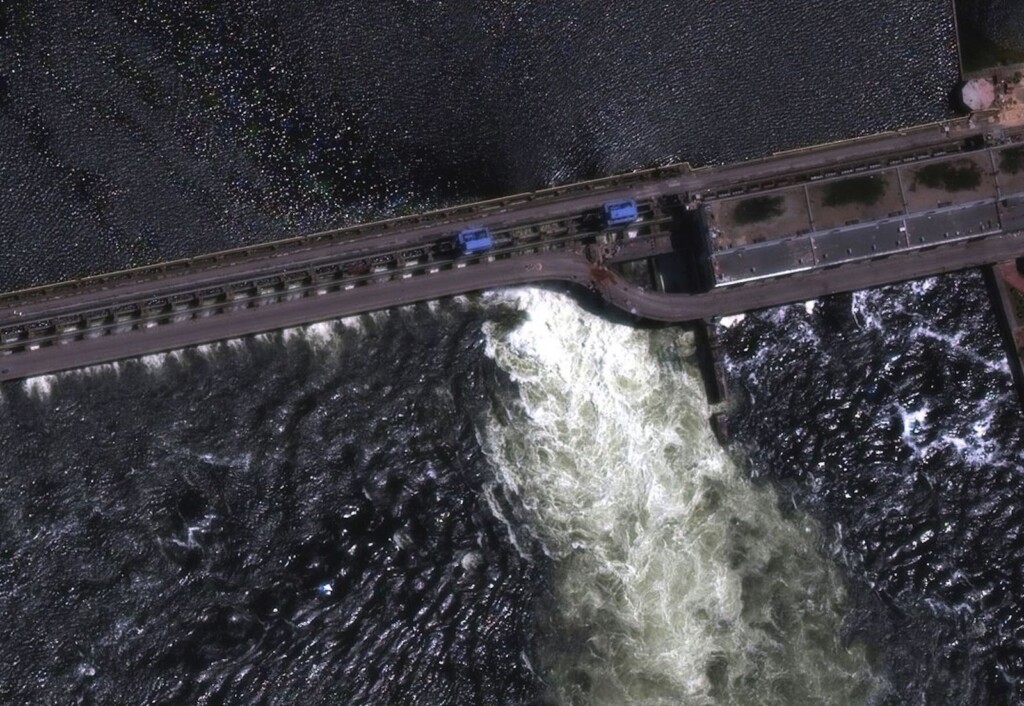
top-left (0, 111), bottom-right (1024, 381)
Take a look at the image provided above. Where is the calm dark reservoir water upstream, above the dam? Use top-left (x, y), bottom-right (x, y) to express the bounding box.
top-left (0, 0), bottom-right (956, 288)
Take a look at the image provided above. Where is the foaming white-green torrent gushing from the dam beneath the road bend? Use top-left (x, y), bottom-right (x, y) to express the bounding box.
top-left (484, 289), bottom-right (878, 706)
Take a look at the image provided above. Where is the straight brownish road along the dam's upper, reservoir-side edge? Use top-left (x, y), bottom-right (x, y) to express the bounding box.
top-left (0, 119), bottom-right (991, 313)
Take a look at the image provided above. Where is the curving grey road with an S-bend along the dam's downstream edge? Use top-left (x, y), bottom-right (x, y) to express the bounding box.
top-left (0, 232), bottom-right (1024, 381)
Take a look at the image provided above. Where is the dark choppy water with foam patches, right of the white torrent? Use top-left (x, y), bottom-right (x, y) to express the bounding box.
top-left (726, 274), bottom-right (1024, 705)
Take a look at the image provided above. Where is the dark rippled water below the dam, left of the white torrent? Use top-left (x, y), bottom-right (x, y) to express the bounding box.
top-left (0, 307), bottom-right (546, 704)
